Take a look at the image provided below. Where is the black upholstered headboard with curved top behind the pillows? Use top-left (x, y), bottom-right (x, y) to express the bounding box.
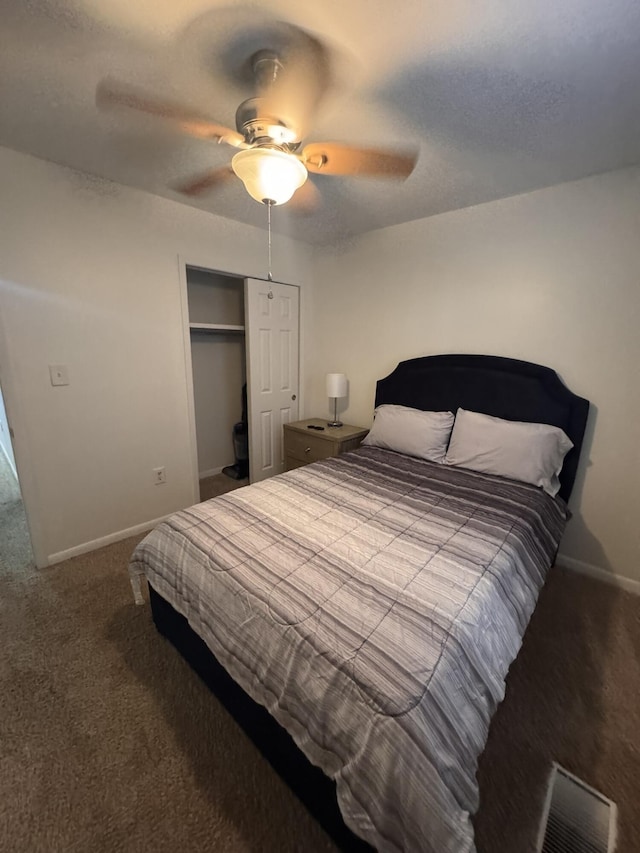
top-left (376, 355), bottom-right (589, 500)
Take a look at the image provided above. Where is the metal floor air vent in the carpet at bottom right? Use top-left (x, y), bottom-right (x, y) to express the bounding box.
top-left (538, 764), bottom-right (617, 853)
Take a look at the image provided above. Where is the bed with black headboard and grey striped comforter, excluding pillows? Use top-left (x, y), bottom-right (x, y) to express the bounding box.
top-left (130, 355), bottom-right (588, 853)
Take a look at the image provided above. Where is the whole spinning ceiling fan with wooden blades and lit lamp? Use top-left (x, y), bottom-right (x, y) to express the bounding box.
top-left (96, 25), bottom-right (416, 208)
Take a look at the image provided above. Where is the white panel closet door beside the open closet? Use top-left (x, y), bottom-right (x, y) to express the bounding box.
top-left (244, 278), bottom-right (300, 483)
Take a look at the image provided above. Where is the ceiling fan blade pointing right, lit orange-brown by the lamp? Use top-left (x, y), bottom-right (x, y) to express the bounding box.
top-left (301, 142), bottom-right (418, 179)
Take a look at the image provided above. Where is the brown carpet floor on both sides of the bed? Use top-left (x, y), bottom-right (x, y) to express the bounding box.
top-left (0, 500), bottom-right (640, 853)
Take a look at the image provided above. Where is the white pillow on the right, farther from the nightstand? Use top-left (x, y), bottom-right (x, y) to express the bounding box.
top-left (445, 409), bottom-right (573, 497)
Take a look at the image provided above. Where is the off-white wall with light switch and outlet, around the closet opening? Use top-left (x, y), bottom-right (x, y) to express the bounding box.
top-left (0, 149), bottom-right (310, 564)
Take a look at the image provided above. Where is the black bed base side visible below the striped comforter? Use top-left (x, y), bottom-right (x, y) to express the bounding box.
top-left (149, 586), bottom-right (373, 853)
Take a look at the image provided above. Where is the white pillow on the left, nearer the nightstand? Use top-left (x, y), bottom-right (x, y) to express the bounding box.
top-left (362, 405), bottom-right (455, 462)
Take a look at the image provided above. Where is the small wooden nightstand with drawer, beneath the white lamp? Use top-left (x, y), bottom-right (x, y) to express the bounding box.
top-left (284, 418), bottom-right (369, 471)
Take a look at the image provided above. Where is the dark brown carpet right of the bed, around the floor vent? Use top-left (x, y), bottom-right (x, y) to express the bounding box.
top-left (476, 569), bottom-right (640, 853)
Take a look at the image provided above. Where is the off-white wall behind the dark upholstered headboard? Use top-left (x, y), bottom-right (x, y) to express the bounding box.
top-left (307, 169), bottom-right (640, 580)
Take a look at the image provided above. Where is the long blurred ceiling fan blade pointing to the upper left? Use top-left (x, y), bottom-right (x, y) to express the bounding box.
top-left (96, 78), bottom-right (246, 148)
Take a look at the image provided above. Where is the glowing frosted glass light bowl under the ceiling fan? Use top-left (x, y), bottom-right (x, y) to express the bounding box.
top-left (231, 148), bottom-right (307, 204)
